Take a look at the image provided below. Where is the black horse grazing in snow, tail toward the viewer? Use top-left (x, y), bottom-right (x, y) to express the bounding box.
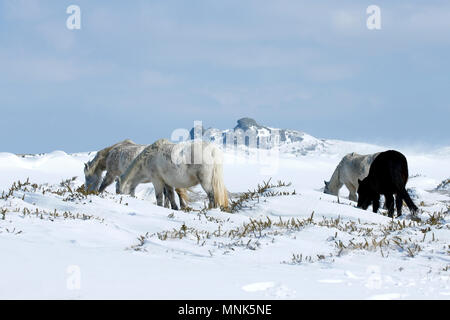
top-left (358, 150), bottom-right (417, 217)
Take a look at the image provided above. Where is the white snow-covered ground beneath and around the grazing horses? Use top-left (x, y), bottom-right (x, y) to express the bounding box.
top-left (0, 141), bottom-right (450, 299)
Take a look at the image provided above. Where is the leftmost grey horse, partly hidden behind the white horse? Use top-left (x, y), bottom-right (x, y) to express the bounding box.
top-left (84, 139), bottom-right (188, 207)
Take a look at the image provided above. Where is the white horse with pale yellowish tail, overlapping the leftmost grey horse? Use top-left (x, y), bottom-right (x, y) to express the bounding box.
top-left (117, 141), bottom-right (228, 208)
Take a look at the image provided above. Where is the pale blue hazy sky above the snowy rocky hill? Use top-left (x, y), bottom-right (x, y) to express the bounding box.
top-left (0, 0), bottom-right (450, 153)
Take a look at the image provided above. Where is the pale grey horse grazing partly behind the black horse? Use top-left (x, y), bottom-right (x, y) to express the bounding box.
top-left (323, 152), bottom-right (380, 201)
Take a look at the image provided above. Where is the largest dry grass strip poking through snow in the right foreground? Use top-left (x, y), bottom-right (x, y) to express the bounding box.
top-left (131, 204), bottom-right (450, 264)
